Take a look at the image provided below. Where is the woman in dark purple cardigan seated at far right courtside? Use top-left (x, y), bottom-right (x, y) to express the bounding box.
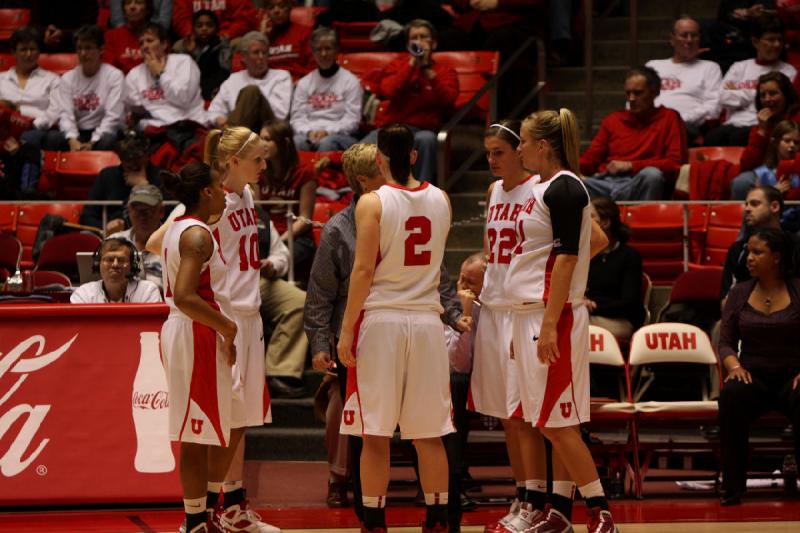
top-left (719, 228), bottom-right (800, 505)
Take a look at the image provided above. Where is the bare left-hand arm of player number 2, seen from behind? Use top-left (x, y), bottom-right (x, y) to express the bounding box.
top-left (336, 193), bottom-right (381, 367)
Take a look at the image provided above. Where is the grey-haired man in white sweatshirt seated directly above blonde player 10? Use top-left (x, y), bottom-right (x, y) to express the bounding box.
top-left (208, 31), bottom-right (292, 126)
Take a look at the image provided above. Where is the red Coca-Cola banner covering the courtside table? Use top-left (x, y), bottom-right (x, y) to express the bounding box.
top-left (0, 304), bottom-right (181, 505)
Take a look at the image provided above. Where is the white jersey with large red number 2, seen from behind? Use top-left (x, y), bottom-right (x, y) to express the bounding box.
top-left (364, 182), bottom-right (451, 313)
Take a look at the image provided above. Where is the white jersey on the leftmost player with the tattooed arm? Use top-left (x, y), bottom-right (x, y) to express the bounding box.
top-left (161, 216), bottom-right (230, 320)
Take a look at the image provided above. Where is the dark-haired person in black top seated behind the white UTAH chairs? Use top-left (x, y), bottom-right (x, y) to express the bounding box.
top-left (583, 196), bottom-right (645, 340)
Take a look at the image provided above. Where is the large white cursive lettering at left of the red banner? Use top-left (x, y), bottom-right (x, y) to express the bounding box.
top-left (0, 333), bottom-right (78, 477)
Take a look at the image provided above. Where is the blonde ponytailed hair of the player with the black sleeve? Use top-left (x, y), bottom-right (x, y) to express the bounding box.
top-left (522, 107), bottom-right (580, 176)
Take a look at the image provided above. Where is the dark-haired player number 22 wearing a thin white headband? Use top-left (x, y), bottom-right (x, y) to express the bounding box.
top-left (470, 120), bottom-right (574, 533)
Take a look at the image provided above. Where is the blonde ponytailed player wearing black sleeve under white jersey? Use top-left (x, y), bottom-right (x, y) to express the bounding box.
top-left (505, 109), bottom-right (618, 533)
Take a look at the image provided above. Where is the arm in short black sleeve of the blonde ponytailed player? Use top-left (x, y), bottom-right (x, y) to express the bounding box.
top-left (537, 175), bottom-right (589, 364)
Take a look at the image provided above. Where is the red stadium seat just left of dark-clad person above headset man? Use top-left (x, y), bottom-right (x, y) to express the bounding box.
top-left (55, 150), bottom-right (120, 200)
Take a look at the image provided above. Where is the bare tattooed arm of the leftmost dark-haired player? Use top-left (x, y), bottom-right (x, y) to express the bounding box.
top-left (172, 226), bottom-right (236, 363)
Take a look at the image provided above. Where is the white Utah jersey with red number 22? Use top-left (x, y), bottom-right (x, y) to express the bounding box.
top-left (480, 174), bottom-right (539, 307)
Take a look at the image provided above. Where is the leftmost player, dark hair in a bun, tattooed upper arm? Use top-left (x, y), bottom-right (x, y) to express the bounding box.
top-left (161, 163), bottom-right (237, 533)
